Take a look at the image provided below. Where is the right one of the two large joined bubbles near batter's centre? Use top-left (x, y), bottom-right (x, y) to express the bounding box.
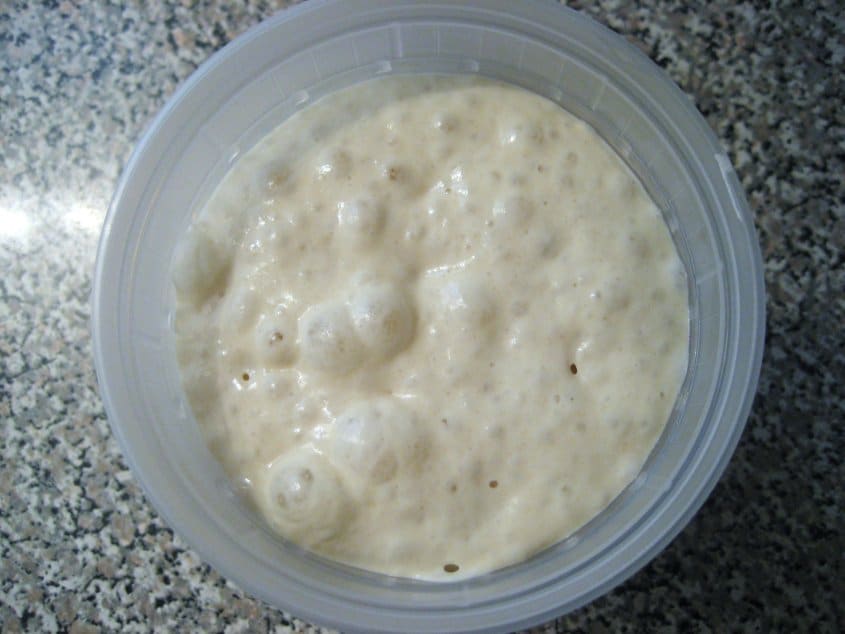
top-left (349, 284), bottom-right (416, 358)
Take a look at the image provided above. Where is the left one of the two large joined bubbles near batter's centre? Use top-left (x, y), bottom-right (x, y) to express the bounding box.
top-left (298, 302), bottom-right (364, 374)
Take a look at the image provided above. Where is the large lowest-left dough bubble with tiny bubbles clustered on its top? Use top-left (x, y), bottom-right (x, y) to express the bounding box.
top-left (262, 446), bottom-right (352, 545)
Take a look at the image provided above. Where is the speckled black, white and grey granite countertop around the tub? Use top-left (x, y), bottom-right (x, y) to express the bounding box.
top-left (0, 0), bottom-right (845, 632)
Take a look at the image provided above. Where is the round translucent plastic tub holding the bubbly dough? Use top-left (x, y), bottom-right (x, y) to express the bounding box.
top-left (92, 0), bottom-right (764, 632)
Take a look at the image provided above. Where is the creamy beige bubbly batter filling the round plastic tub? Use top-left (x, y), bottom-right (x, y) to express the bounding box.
top-left (174, 76), bottom-right (689, 579)
